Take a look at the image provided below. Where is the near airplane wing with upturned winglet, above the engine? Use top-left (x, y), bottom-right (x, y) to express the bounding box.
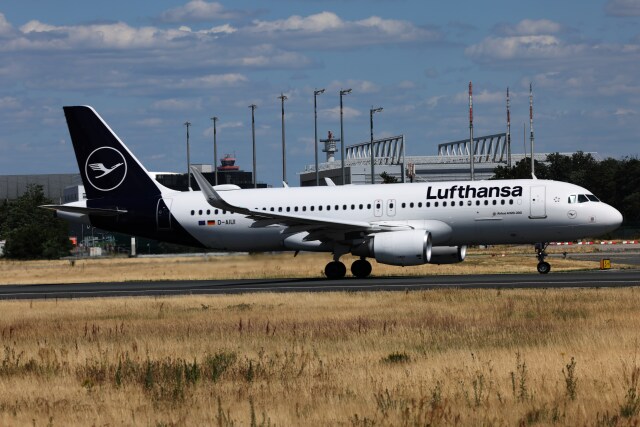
top-left (191, 166), bottom-right (404, 232)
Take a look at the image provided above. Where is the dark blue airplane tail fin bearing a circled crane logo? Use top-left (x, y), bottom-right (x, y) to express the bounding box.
top-left (63, 106), bottom-right (160, 199)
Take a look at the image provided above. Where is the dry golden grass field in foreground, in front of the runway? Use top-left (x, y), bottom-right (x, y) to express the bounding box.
top-left (0, 289), bottom-right (640, 426)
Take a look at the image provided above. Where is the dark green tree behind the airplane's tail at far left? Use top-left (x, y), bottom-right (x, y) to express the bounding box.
top-left (0, 185), bottom-right (71, 259)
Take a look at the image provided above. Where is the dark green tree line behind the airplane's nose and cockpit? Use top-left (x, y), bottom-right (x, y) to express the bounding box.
top-left (493, 151), bottom-right (640, 224)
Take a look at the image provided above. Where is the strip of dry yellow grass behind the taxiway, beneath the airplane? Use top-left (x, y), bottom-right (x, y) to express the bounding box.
top-left (0, 246), bottom-right (620, 285)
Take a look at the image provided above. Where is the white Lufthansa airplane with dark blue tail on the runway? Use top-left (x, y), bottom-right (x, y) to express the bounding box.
top-left (46, 106), bottom-right (622, 279)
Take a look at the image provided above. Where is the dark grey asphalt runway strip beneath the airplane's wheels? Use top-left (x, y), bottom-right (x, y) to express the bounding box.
top-left (0, 269), bottom-right (640, 300)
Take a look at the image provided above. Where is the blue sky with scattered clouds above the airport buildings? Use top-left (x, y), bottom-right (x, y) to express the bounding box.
top-left (0, 0), bottom-right (640, 185)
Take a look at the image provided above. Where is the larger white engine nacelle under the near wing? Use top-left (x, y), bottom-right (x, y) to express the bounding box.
top-left (368, 230), bottom-right (431, 267)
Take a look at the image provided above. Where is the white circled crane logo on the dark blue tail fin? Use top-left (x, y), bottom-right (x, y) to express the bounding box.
top-left (84, 147), bottom-right (127, 191)
